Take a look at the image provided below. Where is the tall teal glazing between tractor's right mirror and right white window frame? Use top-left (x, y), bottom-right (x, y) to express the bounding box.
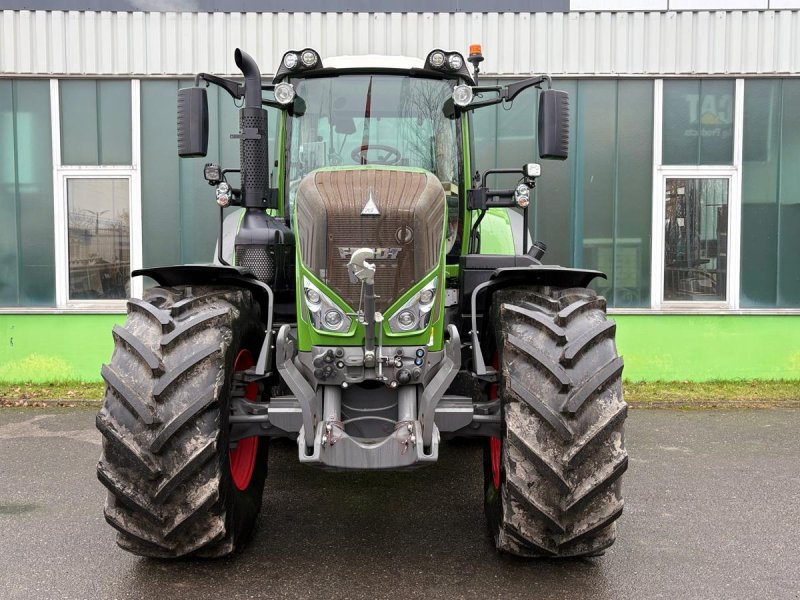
top-left (575, 81), bottom-right (653, 307)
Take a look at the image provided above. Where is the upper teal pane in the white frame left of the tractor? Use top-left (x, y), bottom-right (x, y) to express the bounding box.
top-left (59, 79), bottom-right (132, 165)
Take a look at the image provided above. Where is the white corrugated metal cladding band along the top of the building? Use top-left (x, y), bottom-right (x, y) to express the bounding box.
top-left (0, 10), bottom-right (800, 76)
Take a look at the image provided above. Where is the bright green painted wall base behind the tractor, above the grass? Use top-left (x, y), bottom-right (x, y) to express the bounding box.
top-left (0, 314), bottom-right (800, 383)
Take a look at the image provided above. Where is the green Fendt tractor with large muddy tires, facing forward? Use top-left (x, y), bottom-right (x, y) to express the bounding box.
top-left (97, 47), bottom-right (627, 558)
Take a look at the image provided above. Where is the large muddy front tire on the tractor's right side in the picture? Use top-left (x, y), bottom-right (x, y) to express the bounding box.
top-left (484, 287), bottom-right (628, 558)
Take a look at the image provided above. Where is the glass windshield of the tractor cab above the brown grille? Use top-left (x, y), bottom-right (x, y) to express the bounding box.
top-left (289, 75), bottom-right (458, 205)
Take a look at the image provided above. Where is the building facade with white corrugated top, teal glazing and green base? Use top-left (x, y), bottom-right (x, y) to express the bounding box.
top-left (0, 0), bottom-right (800, 381)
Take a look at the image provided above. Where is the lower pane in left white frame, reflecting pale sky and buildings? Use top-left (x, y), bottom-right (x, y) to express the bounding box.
top-left (67, 178), bottom-right (130, 300)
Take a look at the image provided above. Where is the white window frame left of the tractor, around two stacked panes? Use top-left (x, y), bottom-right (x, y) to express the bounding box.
top-left (49, 79), bottom-right (143, 313)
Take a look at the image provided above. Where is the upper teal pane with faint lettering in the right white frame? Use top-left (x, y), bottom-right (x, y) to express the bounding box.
top-left (662, 79), bottom-right (734, 165)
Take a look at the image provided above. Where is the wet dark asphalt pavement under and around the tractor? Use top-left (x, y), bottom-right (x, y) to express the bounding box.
top-left (0, 409), bottom-right (800, 600)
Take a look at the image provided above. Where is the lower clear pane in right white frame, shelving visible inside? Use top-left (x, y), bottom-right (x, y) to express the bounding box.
top-left (664, 178), bottom-right (728, 301)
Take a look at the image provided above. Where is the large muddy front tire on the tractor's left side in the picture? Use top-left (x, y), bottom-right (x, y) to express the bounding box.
top-left (97, 286), bottom-right (267, 558)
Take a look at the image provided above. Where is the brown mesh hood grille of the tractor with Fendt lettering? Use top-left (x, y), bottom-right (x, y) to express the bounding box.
top-left (296, 166), bottom-right (445, 312)
